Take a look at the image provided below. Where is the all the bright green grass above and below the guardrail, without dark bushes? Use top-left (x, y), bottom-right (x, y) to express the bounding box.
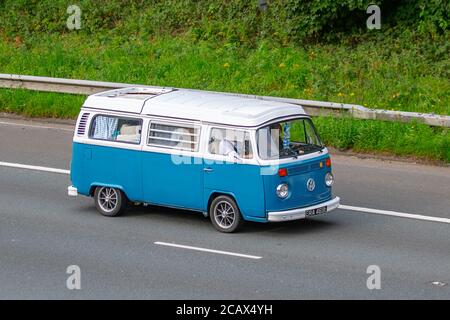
top-left (0, 31), bottom-right (450, 163)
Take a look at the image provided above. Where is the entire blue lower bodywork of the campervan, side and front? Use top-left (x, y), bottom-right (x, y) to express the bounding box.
top-left (71, 143), bottom-right (332, 222)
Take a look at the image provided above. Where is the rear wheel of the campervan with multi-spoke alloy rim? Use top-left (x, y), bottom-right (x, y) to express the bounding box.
top-left (94, 187), bottom-right (127, 217)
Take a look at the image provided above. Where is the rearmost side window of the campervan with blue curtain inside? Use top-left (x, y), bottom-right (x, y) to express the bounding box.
top-left (89, 115), bottom-right (142, 144)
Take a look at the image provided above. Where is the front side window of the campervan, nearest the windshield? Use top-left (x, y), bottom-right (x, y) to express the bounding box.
top-left (208, 128), bottom-right (253, 159)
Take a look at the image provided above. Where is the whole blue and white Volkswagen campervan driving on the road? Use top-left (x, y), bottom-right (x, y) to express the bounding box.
top-left (68, 87), bottom-right (339, 232)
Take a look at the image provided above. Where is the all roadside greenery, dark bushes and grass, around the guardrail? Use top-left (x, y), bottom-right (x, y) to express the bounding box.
top-left (0, 0), bottom-right (450, 162)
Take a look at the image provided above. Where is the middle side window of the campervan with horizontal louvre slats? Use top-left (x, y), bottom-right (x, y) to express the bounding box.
top-left (148, 121), bottom-right (200, 151)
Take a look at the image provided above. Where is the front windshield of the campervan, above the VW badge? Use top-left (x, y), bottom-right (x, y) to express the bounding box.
top-left (256, 118), bottom-right (324, 160)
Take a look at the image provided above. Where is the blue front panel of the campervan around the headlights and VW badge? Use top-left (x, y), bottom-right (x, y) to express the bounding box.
top-left (263, 155), bottom-right (332, 211)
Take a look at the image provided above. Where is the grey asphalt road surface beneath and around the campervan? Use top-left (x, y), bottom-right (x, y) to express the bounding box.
top-left (0, 119), bottom-right (450, 299)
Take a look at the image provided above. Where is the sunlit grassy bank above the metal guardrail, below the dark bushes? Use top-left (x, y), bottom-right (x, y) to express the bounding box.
top-left (0, 34), bottom-right (450, 114)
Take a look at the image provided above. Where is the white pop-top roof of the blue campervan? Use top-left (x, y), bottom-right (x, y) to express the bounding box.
top-left (84, 87), bottom-right (305, 127)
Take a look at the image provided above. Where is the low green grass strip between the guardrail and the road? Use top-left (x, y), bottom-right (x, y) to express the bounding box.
top-left (0, 89), bottom-right (450, 163)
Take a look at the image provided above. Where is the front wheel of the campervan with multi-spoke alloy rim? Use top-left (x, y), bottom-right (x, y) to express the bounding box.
top-left (209, 196), bottom-right (244, 233)
